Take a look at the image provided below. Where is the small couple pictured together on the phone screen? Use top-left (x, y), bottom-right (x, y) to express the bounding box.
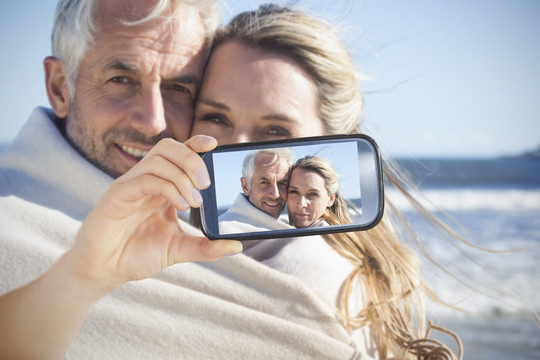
top-left (218, 148), bottom-right (350, 234)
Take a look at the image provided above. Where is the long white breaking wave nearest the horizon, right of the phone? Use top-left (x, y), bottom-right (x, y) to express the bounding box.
top-left (386, 188), bottom-right (540, 211)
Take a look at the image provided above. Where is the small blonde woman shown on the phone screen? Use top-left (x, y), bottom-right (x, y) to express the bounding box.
top-left (287, 155), bottom-right (351, 227)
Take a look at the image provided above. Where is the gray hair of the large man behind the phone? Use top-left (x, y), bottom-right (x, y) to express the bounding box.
top-left (51, 0), bottom-right (221, 97)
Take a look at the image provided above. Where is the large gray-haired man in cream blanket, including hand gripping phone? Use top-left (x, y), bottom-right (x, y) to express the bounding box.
top-left (0, 0), bottom-right (362, 359)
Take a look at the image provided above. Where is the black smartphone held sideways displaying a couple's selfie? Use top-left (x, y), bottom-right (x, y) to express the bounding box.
top-left (199, 134), bottom-right (384, 240)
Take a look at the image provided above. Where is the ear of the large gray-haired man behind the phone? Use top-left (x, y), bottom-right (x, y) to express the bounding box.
top-left (43, 56), bottom-right (70, 119)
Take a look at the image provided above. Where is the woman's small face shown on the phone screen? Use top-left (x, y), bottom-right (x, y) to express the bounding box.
top-left (287, 168), bottom-right (335, 227)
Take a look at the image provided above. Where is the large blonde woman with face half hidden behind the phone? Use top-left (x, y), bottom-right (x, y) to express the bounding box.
top-left (192, 5), bottom-right (462, 359)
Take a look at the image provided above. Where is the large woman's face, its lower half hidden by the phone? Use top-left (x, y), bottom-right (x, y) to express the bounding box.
top-left (192, 41), bottom-right (324, 145)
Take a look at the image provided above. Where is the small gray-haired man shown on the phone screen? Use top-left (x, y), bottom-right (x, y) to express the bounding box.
top-left (218, 149), bottom-right (292, 234)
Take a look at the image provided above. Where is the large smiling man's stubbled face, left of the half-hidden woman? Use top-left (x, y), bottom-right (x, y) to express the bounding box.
top-left (66, 0), bottom-right (205, 177)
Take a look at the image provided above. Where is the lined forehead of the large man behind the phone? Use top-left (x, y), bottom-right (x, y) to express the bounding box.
top-left (91, 0), bottom-right (206, 79)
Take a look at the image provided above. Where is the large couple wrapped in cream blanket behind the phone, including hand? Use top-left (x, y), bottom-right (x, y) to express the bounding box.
top-left (0, 0), bottom-right (464, 359)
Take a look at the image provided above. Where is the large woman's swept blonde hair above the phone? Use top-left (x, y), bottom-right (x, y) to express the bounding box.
top-left (214, 5), bottom-right (363, 134)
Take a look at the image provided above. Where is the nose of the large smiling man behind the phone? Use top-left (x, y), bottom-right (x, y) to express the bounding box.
top-left (134, 86), bottom-right (167, 137)
